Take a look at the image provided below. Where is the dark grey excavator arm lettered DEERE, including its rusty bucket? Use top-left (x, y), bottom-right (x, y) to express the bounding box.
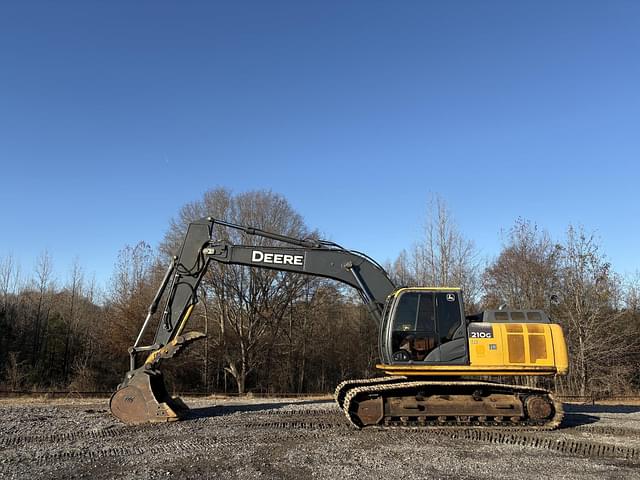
top-left (110, 217), bottom-right (395, 423)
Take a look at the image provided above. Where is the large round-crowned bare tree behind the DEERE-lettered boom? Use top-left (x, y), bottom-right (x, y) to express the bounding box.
top-left (161, 189), bottom-right (308, 393)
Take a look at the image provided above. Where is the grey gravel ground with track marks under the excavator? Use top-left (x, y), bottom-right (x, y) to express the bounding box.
top-left (0, 399), bottom-right (640, 480)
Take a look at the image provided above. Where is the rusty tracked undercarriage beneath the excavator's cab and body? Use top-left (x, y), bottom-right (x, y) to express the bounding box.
top-left (336, 377), bottom-right (563, 430)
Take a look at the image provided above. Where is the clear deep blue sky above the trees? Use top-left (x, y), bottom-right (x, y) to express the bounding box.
top-left (0, 0), bottom-right (640, 288)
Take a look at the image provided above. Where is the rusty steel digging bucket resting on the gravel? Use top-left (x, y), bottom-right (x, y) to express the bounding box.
top-left (109, 367), bottom-right (189, 424)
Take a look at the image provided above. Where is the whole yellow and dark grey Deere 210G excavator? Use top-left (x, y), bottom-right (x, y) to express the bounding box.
top-left (110, 217), bottom-right (568, 430)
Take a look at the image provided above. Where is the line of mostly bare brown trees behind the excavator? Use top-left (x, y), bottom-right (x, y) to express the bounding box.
top-left (0, 189), bottom-right (640, 395)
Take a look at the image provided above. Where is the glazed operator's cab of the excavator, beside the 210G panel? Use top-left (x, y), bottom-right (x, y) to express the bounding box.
top-left (380, 288), bottom-right (469, 365)
